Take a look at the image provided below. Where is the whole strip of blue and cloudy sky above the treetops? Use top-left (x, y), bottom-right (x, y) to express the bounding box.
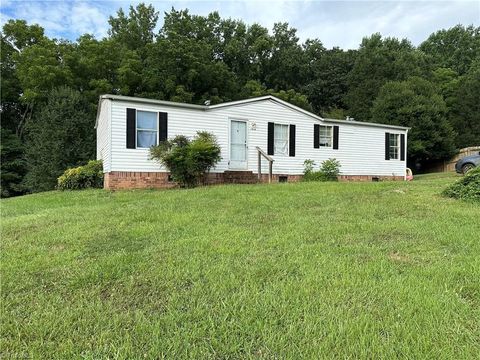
top-left (0, 0), bottom-right (480, 49)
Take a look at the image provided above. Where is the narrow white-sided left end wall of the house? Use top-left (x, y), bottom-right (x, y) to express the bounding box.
top-left (97, 99), bottom-right (112, 172)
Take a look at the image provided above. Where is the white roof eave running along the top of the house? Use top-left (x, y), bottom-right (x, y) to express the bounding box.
top-left (95, 94), bottom-right (410, 130)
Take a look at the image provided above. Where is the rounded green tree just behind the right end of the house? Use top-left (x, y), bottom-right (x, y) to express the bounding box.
top-left (372, 77), bottom-right (455, 164)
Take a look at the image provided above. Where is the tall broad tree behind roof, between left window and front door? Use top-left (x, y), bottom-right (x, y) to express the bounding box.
top-left (143, 9), bottom-right (239, 103)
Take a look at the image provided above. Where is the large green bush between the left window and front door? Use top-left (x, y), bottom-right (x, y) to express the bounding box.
top-left (150, 131), bottom-right (221, 188)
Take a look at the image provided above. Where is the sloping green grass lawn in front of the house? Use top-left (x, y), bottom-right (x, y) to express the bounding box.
top-left (0, 174), bottom-right (480, 359)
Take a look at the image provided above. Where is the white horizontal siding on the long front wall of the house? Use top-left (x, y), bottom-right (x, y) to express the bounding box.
top-left (107, 100), bottom-right (406, 176)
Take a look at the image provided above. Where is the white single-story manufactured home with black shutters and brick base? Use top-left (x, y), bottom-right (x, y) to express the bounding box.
top-left (96, 95), bottom-right (408, 189)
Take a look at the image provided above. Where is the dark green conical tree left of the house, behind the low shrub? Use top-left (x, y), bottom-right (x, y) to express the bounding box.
top-left (24, 87), bottom-right (95, 192)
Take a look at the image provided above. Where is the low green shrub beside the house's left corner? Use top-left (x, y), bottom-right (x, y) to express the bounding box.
top-left (57, 160), bottom-right (103, 190)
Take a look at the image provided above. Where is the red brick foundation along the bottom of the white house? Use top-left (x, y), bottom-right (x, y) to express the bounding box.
top-left (103, 171), bottom-right (403, 190)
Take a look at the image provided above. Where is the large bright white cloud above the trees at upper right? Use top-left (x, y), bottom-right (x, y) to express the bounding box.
top-left (295, 1), bottom-right (480, 49)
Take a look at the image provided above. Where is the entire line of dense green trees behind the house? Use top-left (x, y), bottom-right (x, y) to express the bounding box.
top-left (1, 4), bottom-right (480, 197)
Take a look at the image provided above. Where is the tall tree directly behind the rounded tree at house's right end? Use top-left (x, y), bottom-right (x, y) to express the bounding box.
top-left (345, 34), bottom-right (423, 121)
